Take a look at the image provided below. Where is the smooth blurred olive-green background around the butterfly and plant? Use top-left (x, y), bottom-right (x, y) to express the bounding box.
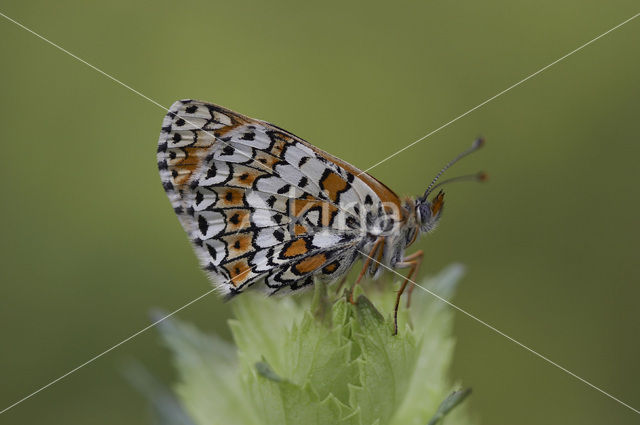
top-left (0, 0), bottom-right (640, 424)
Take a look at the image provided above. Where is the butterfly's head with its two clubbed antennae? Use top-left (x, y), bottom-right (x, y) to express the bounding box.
top-left (416, 138), bottom-right (487, 233)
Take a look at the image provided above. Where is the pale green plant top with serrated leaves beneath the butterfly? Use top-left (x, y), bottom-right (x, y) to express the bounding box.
top-left (139, 266), bottom-right (480, 425)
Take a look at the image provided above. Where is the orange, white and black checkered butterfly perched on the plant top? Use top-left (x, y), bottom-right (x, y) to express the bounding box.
top-left (157, 99), bottom-right (484, 332)
